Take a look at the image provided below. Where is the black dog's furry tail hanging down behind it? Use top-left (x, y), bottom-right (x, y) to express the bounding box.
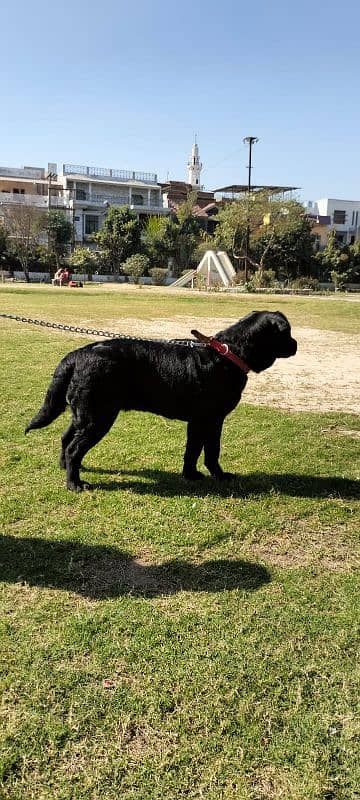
top-left (25, 353), bottom-right (75, 433)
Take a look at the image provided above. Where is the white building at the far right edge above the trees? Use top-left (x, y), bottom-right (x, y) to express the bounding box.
top-left (305, 197), bottom-right (360, 244)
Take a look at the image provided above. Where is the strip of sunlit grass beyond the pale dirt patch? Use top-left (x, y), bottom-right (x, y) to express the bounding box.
top-left (0, 284), bottom-right (359, 333)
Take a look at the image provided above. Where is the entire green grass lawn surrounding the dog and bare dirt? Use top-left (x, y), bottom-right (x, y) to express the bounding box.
top-left (0, 286), bottom-right (360, 800)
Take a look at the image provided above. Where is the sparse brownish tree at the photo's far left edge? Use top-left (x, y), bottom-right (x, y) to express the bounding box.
top-left (2, 203), bottom-right (46, 282)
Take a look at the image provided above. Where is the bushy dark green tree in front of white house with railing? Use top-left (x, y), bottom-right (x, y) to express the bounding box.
top-left (94, 206), bottom-right (140, 272)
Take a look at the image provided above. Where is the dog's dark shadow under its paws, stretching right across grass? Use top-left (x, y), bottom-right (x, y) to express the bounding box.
top-left (83, 467), bottom-right (360, 499)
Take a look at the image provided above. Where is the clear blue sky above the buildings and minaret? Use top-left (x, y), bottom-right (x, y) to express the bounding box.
top-left (0, 0), bottom-right (360, 200)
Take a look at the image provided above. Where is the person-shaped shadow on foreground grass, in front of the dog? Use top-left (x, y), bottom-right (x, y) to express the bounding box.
top-left (0, 536), bottom-right (271, 600)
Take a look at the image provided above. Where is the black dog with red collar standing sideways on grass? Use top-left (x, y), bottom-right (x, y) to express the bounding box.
top-left (25, 311), bottom-right (297, 492)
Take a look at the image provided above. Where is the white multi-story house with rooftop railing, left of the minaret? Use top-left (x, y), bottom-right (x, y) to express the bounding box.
top-left (59, 164), bottom-right (169, 244)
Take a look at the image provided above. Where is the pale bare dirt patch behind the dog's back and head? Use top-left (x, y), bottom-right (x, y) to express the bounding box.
top-left (100, 316), bottom-right (360, 414)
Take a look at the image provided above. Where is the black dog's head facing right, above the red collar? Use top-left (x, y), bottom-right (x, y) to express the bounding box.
top-left (222, 311), bottom-right (297, 372)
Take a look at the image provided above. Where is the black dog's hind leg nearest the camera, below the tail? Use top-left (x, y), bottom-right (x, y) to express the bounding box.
top-left (65, 410), bottom-right (118, 492)
